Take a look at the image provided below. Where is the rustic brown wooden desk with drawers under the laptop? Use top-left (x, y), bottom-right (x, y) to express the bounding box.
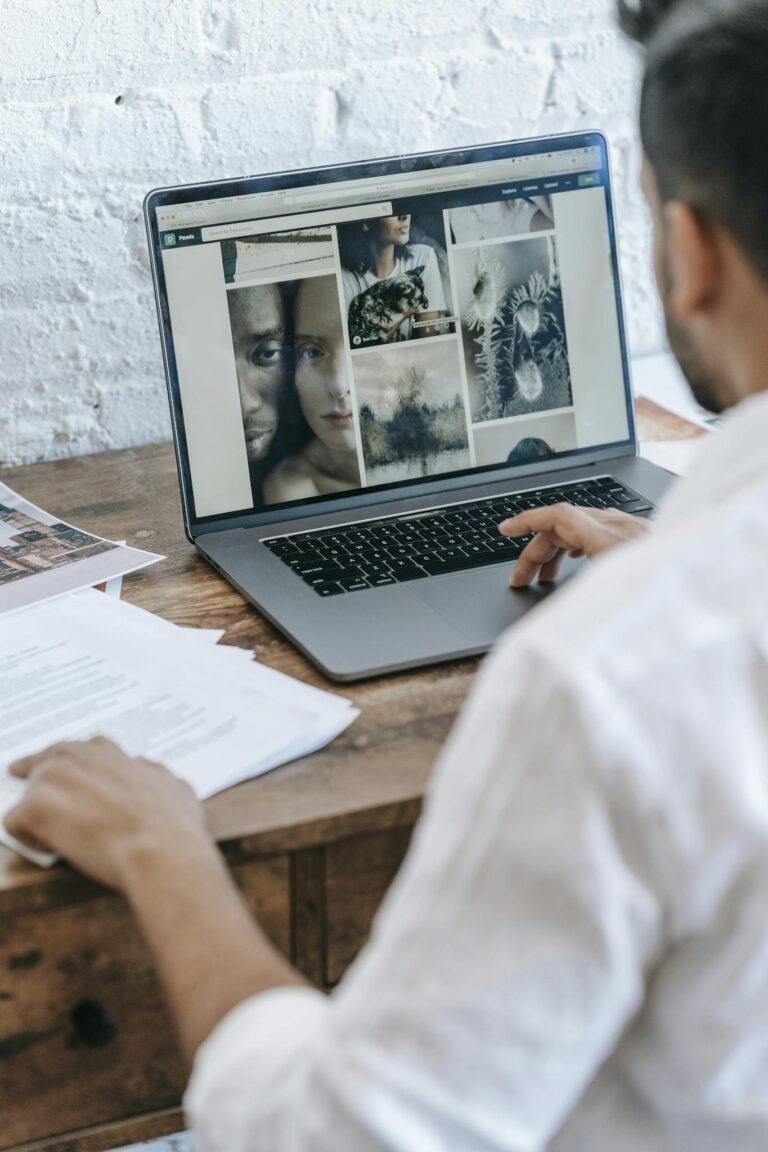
top-left (0, 445), bottom-right (477, 1152)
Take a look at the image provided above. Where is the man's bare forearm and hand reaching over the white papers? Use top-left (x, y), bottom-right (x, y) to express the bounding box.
top-left (6, 737), bottom-right (304, 1063)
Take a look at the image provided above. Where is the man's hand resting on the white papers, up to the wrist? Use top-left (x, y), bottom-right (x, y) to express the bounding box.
top-left (6, 736), bottom-right (207, 890)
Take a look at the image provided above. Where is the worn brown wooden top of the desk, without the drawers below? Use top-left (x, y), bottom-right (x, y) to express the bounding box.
top-left (0, 445), bottom-right (477, 914)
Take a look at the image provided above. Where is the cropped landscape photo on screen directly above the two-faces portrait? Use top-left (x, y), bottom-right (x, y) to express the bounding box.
top-left (221, 228), bottom-right (335, 285)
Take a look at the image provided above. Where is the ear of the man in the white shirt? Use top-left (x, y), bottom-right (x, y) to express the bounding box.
top-left (662, 200), bottom-right (720, 320)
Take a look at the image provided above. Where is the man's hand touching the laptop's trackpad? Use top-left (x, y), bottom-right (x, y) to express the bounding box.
top-left (499, 503), bottom-right (651, 588)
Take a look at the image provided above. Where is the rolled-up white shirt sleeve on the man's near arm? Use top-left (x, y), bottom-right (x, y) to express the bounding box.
top-left (187, 646), bottom-right (662, 1152)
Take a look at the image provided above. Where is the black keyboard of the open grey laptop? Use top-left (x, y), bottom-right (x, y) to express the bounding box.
top-left (263, 476), bottom-right (653, 597)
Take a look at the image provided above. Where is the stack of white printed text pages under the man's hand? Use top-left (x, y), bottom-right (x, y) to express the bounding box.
top-left (0, 591), bottom-right (358, 863)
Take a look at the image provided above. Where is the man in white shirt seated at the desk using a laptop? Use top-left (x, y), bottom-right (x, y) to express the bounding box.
top-left (8, 0), bottom-right (768, 1152)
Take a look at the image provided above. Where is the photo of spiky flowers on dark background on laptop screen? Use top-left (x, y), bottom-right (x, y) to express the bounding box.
top-left (453, 236), bottom-right (572, 424)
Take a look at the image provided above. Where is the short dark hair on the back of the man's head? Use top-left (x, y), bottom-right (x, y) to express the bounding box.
top-left (618, 0), bottom-right (768, 280)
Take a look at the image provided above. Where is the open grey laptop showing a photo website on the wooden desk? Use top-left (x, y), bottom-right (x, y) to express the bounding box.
top-left (144, 132), bottom-right (672, 681)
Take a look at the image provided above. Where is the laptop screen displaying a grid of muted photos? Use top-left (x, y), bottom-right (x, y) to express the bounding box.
top-left (147, 136), bottom-right (632, 520)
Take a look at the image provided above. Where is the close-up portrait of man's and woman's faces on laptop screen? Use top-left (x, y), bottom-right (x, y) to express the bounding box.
top-left (227, 275), bottom-right (360, 507)
